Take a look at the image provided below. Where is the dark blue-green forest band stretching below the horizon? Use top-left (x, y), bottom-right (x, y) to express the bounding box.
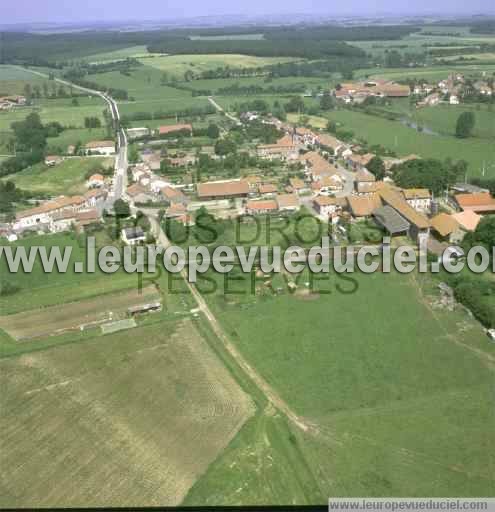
top-left (0, 25), bottom-right (419, 67)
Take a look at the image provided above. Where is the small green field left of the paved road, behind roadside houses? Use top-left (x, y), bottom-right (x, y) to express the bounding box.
top-left (7, 157), bottom-right (113, 195)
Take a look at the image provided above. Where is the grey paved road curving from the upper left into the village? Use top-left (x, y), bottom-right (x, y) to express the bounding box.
top-left (18, 66), bottom-right (128, 210)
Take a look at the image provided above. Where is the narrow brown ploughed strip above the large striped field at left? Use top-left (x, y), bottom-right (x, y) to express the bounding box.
top-left (0, 285), bottom-right (161, 341)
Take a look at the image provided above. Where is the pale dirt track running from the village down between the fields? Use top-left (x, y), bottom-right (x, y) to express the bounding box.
top-left (147, 214), bottom-right (315, 432)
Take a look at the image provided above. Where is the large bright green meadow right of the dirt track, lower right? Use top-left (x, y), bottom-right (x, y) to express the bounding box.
top-left (185, 268), bottom-right (495, 505)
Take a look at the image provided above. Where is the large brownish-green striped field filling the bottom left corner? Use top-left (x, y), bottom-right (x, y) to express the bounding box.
top-left (0, 320), bottom-right (254, 507)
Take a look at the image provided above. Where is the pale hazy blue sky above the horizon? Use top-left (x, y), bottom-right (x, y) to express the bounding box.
top-left (0, 0), bottom-right (495, 24)
